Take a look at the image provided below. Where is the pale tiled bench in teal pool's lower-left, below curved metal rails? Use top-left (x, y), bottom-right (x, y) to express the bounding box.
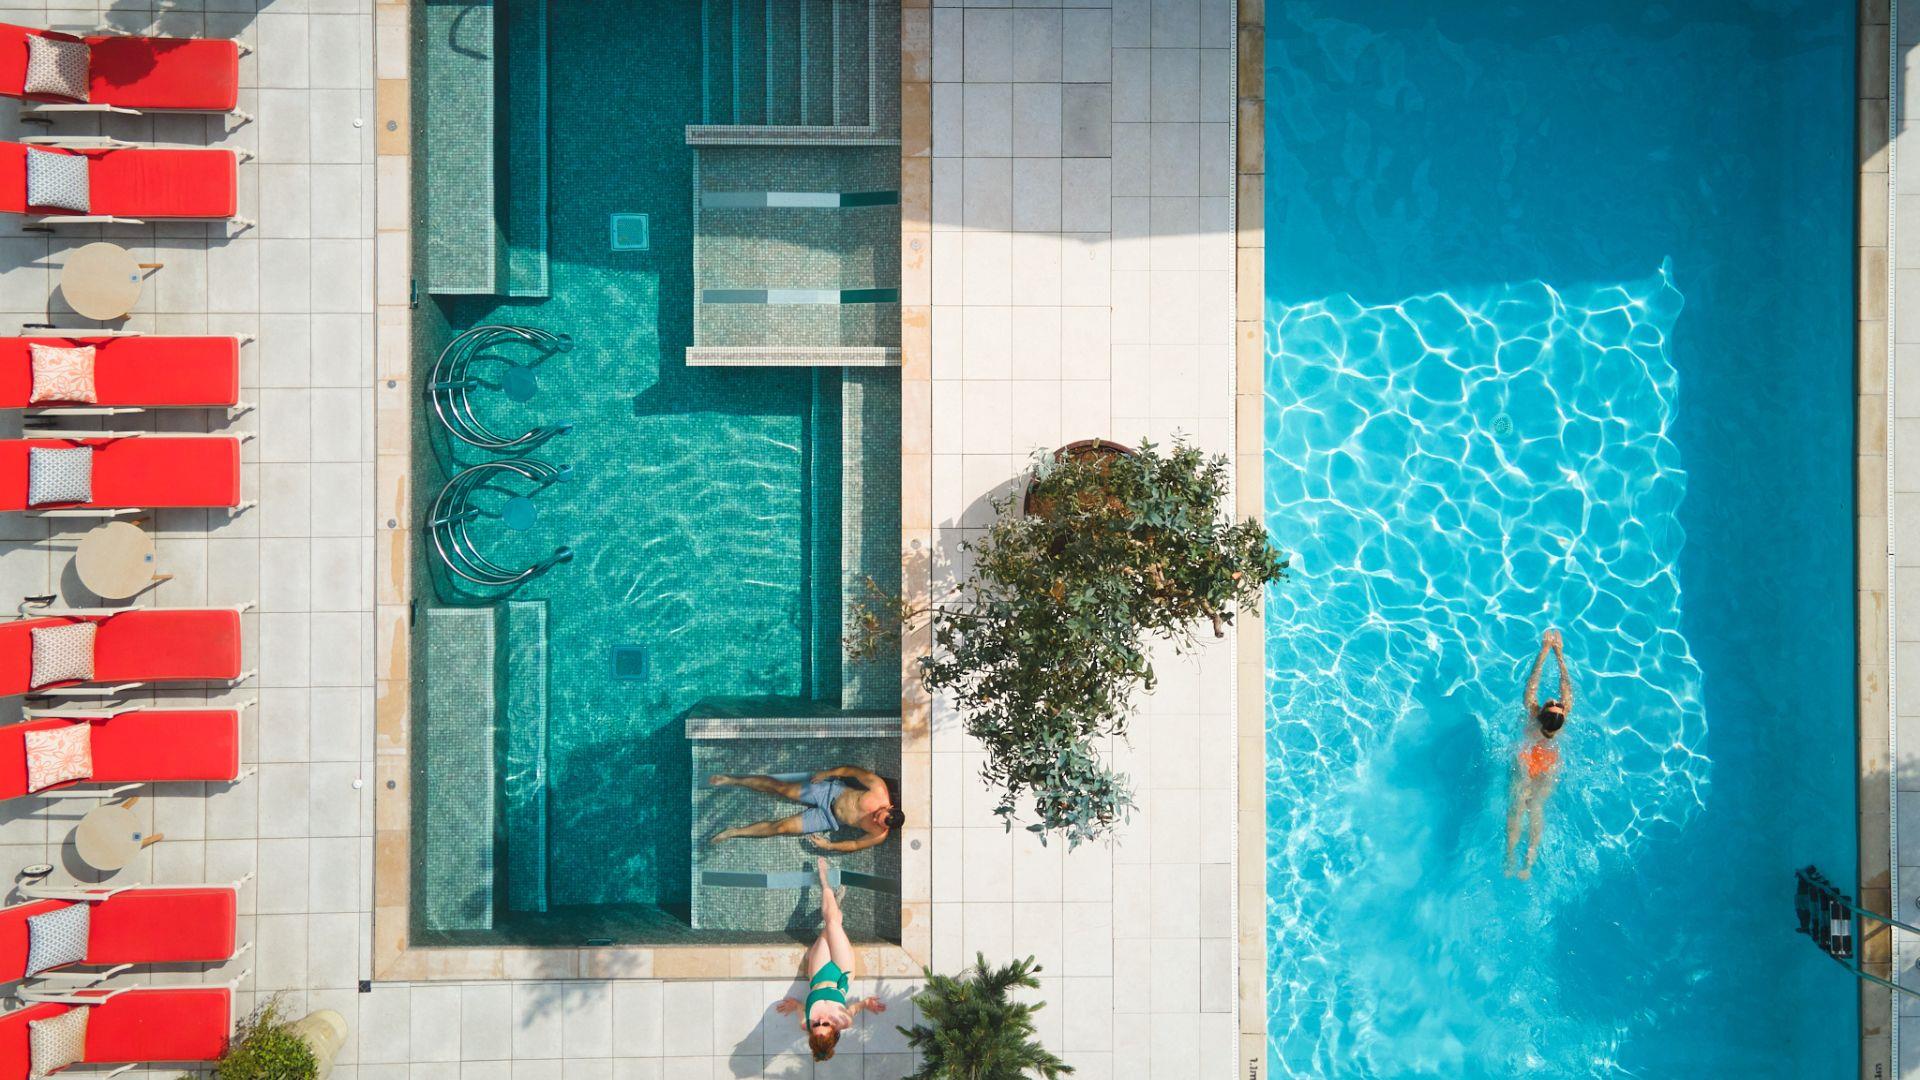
top-left (413, 607), bottom-right (495, 930)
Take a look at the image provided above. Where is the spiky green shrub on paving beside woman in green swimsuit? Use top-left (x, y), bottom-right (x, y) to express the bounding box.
top-left (900, 953), bottom-right (1073, 1080)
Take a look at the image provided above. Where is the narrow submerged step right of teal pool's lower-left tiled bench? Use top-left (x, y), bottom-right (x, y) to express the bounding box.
top-left (499, 600), bottom-right (547, 911)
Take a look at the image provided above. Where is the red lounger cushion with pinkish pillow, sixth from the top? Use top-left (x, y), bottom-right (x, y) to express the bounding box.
top-left (0, 709), bottom-right (240, 799)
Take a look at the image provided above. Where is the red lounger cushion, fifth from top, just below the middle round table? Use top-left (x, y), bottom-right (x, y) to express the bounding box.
top-left (0, 607), bottom-right (240, 691)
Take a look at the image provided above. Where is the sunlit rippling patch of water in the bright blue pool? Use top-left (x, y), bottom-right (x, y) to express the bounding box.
top-left (1265, 267), bottom-right (1711, 1074)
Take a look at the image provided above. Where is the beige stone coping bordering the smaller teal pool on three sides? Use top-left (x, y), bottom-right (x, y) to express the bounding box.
top-left (372, 0), bottom-right (933, 982)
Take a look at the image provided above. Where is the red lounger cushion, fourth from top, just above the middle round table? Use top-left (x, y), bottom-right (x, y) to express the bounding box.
top-left (0, 434), bottom-right (240, 511)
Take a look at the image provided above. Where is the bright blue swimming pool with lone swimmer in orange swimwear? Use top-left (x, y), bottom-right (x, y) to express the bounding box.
top-left (1265, 0), bottom-right (1859, 1076)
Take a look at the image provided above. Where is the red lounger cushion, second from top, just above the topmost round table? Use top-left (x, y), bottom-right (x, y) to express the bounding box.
top-left (0, 142), bottom-right (238, 217)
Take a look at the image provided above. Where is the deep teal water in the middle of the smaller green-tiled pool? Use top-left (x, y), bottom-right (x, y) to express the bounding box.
top-left (415, 0), bottom-right (899, 944)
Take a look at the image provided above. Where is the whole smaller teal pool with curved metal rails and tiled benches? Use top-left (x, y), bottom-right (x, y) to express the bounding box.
top-left (399, 0), bottom-right (899, 945)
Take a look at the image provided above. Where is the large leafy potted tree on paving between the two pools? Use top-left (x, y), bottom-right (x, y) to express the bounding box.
top-left (852, 434), bottom-right (1286, 846)
